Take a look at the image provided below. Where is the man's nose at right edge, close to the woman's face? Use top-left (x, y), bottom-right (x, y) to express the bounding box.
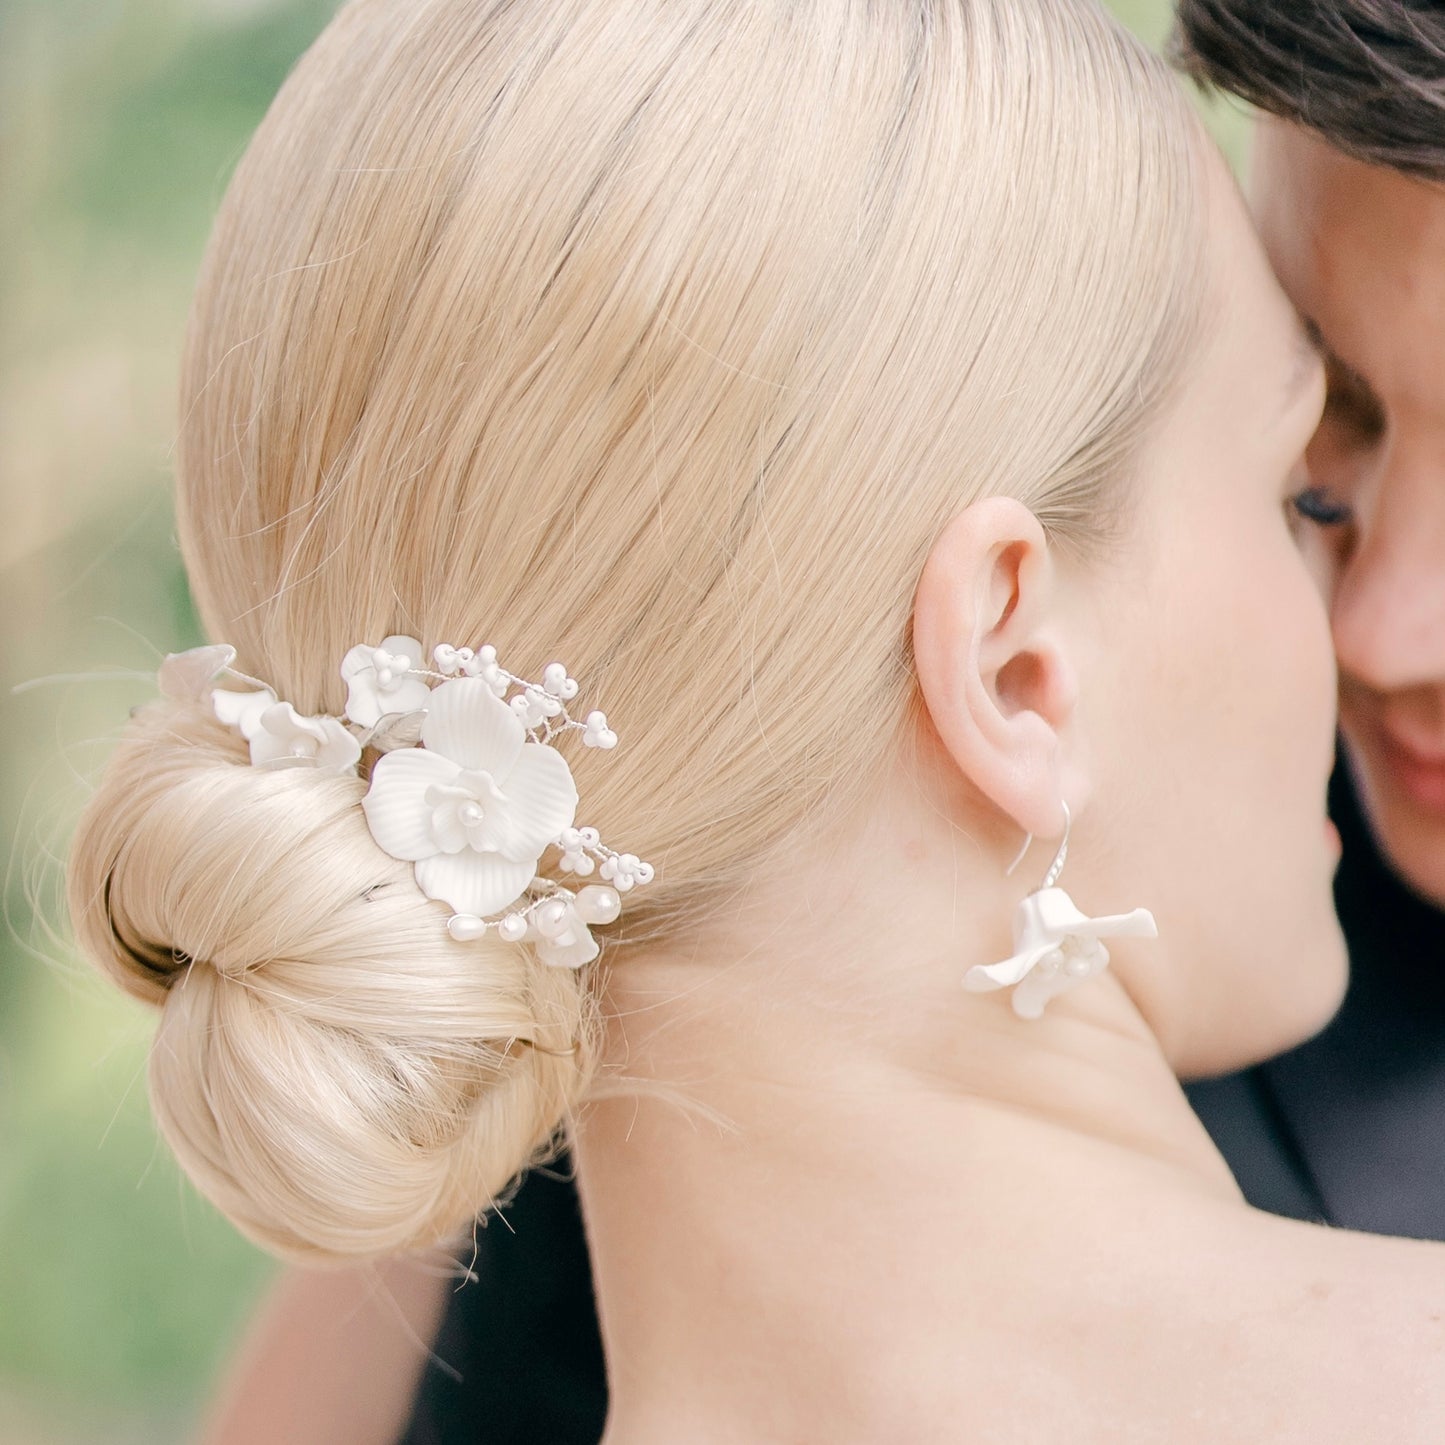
top-left (1332, 458), bottom-right (1445, 692)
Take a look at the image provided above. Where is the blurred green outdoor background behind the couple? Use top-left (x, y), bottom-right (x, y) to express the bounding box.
top-left (0, 0), bottom-right (1246, 1445)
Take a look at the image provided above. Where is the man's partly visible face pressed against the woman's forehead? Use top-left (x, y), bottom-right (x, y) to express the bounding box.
top-left (1250, 120), bottom-right (1445, 906)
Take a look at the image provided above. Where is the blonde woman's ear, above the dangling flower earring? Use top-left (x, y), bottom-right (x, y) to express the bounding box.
top-left (913, 497), bottom-right (1077, 838)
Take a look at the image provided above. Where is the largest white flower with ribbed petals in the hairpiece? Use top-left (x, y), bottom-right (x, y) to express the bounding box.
top-left (361, 673), bottom-right (577, 916)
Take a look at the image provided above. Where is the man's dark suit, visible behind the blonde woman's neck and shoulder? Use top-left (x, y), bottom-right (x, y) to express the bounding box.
top-left (399, 776), bottom-right (1445, 1445)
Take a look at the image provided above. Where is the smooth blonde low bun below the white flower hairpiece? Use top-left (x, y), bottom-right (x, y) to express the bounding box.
top-left (66, 701), bottom-right (591, 1263)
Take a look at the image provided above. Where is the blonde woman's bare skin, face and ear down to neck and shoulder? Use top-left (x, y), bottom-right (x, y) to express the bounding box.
top-left (577, 149), bottom-right (1445, 1445)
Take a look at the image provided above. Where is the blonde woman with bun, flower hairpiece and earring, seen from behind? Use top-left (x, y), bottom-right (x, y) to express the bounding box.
top-left (71, 0), bottom-right (1445, 1445)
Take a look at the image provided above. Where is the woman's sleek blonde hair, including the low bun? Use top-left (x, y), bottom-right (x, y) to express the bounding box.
top-left (69, 0), bottom-right (1205, 1259)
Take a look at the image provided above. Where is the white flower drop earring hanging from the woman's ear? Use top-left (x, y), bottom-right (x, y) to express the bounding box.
top-left (964, 803), bottom-right (1159, 1019)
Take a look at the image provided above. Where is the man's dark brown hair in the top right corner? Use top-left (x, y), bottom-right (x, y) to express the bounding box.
top-left (1172, 0), bottom-right (1445, 181)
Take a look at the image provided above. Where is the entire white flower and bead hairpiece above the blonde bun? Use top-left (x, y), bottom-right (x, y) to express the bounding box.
top-left (159, 636), bottom-right (653, 968)
